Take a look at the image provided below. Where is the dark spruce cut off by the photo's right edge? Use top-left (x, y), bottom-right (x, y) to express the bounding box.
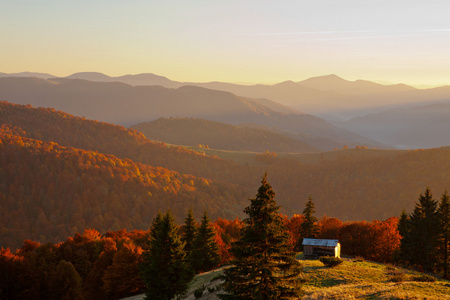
top-left (438, 191), bottom-right (450, 279)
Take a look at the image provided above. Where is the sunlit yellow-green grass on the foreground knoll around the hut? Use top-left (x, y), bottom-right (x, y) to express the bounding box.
top-left (121, 253), bottom-right (450, 300)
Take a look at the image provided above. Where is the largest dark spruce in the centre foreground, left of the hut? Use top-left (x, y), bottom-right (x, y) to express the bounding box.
top-left (219, 174), bottom-right (301, 300)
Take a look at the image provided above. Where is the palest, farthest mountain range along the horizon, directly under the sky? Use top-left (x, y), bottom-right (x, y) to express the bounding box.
top-left (5, 72), bottom-right (450, 120)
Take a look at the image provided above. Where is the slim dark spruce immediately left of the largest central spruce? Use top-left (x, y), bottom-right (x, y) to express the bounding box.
top-left (189, 212), bottom-right (220, 273)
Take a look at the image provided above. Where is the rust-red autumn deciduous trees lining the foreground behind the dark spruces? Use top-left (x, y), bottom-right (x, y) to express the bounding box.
top-left (0, 209), bottom-right (401, 299)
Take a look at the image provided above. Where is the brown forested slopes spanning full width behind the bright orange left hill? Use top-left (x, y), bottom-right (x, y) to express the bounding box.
top-left (0, 102), bottom-right (450, 227)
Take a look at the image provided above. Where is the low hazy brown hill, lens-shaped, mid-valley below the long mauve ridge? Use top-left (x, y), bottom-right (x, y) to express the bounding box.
top-left (131, 118), bottom-right (319, 153)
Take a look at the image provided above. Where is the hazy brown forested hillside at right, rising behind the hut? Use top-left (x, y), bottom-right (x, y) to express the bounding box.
top-left (268, 147), bottom-right (450, 220)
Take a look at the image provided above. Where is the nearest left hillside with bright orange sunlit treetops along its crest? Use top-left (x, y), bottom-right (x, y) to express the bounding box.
top-left (0, 132), bottom-right (245, 248)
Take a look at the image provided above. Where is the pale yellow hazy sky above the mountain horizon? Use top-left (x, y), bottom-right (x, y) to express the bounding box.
top-left (0, 0), bottom-right (450, 85)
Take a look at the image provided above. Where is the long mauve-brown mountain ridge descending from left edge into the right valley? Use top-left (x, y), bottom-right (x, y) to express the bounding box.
top-left (0, 78), bottom-right (383, 150)
